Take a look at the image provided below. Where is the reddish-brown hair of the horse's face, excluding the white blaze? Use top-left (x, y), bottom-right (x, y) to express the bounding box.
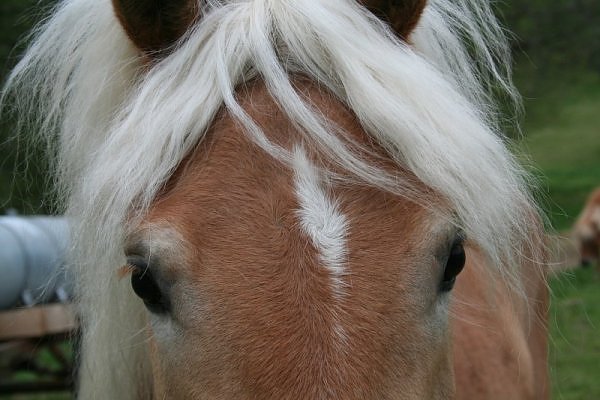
top-left (142, 79), bottom-right (449, 399)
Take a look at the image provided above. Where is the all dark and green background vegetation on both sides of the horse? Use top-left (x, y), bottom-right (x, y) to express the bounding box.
top-left (0, 0), bottom-right (600, 400)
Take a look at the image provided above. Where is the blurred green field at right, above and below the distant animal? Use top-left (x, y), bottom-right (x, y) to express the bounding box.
top-left (517, 71), bottom-right (600, 400)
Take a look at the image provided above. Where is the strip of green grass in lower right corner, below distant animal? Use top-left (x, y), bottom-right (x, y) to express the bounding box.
top-left (550, 268), bottom-right (600, 400)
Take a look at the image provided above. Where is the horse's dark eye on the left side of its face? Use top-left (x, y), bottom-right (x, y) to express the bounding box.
top-left (127, 258), bottom-right (170, 314)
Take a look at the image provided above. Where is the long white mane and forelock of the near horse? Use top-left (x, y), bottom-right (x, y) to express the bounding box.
top-left (3, 0), bottom-right (534, 399)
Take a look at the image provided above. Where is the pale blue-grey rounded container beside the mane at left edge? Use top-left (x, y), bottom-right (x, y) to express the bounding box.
top-left (0, 216), bottom-right (71, 310)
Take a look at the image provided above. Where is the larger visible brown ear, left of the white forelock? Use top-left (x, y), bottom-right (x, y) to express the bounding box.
top-left (112, 0), bottom-right (200, 55)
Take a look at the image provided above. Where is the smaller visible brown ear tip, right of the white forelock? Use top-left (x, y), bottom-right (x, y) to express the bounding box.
top-left (360, 0), bottom-right (427, 40)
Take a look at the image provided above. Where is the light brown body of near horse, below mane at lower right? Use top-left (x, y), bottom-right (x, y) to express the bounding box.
top-left (452, 248), bottom-right (550, 399)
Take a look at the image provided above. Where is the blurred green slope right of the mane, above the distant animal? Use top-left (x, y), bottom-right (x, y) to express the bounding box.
top-left (521, 75), bottom-right (600, 230)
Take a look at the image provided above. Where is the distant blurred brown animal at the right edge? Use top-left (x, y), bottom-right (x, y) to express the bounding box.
top-left (573, 187), bottom-right (600, 266)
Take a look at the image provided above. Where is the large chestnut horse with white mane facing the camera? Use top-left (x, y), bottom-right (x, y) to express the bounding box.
top-left (3, 0), bottom-right (549, 400)
